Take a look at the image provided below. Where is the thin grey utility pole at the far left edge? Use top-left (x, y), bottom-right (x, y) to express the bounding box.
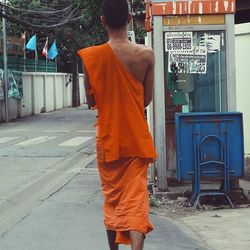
top-left (2, 0), bottom-right (9, 123)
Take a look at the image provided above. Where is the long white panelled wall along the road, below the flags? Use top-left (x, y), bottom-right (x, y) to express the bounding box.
top-left (0, 72), bottom-right (86, 122)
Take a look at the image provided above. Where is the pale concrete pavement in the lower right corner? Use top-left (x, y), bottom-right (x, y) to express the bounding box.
top-left (182, 208), bottom-right (250, 250)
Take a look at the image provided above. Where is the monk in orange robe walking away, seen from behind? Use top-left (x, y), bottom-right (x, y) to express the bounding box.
top-left (78, 0), bottom-right (157, 250)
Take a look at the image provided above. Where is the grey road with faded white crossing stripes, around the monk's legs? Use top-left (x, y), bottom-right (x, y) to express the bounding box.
top-left (0, 108), bottom-right (207, 250)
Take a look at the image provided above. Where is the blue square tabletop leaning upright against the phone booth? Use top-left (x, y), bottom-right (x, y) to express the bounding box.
top-left (175, 113), bottom-right (244, 181)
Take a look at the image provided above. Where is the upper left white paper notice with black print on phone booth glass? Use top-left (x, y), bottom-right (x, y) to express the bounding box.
top-left (165, 32), bottom-right (193, 51)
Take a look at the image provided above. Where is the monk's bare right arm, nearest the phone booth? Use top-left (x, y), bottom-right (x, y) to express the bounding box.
top-left (144, 50), bottom-right (155, 108)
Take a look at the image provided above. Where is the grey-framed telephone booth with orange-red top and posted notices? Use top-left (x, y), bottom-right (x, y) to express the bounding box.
top-left (146, 0), bottom-right (236, 190)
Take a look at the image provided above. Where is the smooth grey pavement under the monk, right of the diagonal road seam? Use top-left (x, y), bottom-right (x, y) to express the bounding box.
top-left (0, 158), bottom-right (208, 250)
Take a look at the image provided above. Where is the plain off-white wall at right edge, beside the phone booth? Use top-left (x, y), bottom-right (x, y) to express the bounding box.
top-left (234, 23), bottom-right (250, 155)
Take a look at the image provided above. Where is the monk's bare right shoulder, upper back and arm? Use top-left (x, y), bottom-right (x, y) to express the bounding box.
top-left (110, 41), bottom-right (154, 107)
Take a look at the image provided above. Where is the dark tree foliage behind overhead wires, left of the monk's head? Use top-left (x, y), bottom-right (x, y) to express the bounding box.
top-left (4, 0), bottom-right (107, 72)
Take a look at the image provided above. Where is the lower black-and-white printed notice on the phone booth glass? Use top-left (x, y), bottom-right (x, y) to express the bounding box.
top-left (168, 46), bottom-right (207, 74)
